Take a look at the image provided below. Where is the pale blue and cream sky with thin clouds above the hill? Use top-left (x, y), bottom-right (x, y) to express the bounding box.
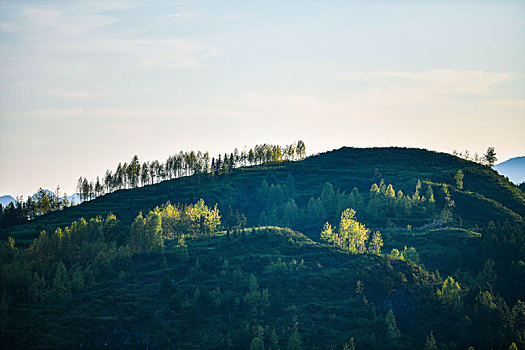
top-left (0, 0), bottom-right (525, 196)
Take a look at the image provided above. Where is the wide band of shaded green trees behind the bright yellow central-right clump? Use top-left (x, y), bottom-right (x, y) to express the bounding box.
top-left (256, 175), bottom-right (444, 229)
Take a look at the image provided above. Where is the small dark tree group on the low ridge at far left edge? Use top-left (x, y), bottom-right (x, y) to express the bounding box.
top-left (0, 186), bottom-right (73, 228)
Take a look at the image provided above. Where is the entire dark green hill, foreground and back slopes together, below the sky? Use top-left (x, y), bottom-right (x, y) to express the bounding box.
top-left (0, 148), bottom-right (525, 350)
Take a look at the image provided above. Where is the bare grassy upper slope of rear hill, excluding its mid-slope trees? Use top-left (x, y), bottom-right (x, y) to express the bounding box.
top-left (8, 148), bottom-right (525, 240)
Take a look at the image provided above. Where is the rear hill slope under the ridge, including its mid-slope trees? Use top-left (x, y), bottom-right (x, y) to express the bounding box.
top-left (4, 147), bottom-right (525, 242)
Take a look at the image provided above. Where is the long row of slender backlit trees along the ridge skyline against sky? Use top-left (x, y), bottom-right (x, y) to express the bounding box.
top-left (77, 140), bottom-right (306, 200)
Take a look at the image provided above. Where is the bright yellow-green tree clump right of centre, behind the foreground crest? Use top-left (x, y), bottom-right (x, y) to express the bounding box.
top-left (321, 209), bottom-right (383, 255)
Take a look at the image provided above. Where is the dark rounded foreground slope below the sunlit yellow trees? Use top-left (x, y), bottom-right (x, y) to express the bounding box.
top-left (2, 224), bottom-right (516, 349)
